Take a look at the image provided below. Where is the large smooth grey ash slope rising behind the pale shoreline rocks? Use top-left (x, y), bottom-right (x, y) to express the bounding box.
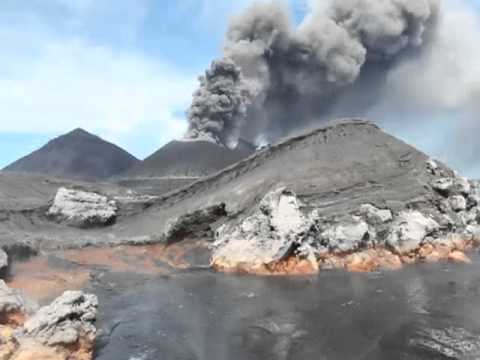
top-left (0, 121), bottom-right (448, 246)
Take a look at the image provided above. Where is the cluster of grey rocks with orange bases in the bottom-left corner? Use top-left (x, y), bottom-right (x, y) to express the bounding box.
top-left (0, 283), bottom-right (98, 360)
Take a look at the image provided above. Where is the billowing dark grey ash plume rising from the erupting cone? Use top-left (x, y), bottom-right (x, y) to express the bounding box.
top-left (187, 0), bottom-right (480, 153)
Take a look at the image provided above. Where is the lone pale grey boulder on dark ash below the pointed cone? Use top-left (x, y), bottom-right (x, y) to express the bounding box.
top-left (47, 188), bottom-right (117, 227)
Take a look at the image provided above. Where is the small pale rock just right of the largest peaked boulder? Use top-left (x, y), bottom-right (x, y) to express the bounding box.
top-left (321, 217), bottom-right (370, 253)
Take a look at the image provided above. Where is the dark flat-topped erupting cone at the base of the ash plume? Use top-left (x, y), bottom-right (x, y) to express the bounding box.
top-left (129, 141), bottom-right (255, 177)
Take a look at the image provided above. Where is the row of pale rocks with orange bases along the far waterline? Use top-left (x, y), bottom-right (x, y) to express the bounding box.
top-left (212, 159), bottom-right (480, 274)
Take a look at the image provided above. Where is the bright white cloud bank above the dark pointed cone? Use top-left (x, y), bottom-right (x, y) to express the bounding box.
top-left (0, 40), bottom-right (196, 135)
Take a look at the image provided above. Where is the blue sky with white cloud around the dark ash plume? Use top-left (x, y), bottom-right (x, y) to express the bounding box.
top-left (0, 0), bottom-right (480, 177)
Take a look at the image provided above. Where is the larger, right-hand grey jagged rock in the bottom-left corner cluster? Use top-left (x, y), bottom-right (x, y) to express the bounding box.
top-left (22, 291), bottom-right (98, 346)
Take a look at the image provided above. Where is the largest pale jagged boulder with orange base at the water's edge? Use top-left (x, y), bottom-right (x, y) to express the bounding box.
top-left (211, 188), bottom-right (311, 269)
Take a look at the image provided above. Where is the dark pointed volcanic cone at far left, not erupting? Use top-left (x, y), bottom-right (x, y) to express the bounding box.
top-left (4, 129), bottom-right (139, 179)
